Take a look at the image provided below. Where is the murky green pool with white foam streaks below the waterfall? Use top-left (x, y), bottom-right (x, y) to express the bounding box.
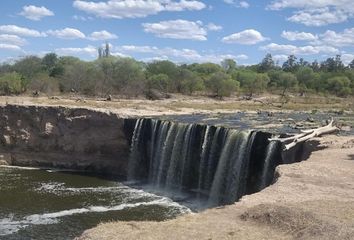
top-left (0, 167), bottom-right (190, 240)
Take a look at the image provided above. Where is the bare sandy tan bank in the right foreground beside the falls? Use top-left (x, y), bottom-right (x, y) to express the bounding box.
top-left (79, 136), bottom-right (354, 240)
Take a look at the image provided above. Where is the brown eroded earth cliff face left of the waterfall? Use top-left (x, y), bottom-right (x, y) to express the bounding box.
top-left (0, 105), bottom-right (129, 176)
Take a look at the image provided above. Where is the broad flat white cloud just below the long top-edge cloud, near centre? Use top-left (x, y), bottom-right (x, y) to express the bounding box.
top-left (143, 19), bottom-right (207, 41)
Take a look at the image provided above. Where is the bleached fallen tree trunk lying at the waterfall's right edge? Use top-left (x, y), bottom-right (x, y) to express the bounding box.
top-left (269, 119), bottom-right (339, 150)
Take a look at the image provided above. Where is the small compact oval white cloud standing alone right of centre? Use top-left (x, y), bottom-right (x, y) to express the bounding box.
top-left (222, 29), bottom-right (267, 45)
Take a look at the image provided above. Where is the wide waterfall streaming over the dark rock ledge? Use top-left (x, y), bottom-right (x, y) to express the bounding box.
top-left (128, 119), bottom-right (281, 206)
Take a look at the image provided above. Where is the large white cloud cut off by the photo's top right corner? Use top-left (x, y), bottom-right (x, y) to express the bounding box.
top-left (267, 0), bottom-right (354, 26)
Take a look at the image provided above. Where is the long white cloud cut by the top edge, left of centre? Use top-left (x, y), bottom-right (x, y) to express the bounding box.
top-left (73, 0), bottom-right (206, 19)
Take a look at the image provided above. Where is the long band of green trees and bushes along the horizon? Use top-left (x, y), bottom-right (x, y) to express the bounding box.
top-left (0, 52), bottom-right (354, 99)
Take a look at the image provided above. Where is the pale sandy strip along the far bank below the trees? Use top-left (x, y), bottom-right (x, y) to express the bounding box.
top-left (0, 95), bottom-right (354, 117)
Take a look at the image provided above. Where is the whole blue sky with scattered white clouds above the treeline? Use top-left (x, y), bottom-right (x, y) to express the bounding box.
top-left (0, 0), bottom-right (354, 65)
